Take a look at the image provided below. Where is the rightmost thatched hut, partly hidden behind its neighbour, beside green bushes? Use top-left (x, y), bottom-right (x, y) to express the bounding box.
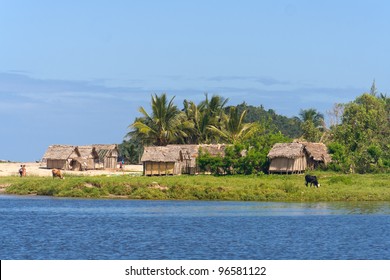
top-left (302, 142), bottom-right (332, 169)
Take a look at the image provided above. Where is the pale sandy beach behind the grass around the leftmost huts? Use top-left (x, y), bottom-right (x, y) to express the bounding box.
top-left (0, 162), bottom-right (142, 177)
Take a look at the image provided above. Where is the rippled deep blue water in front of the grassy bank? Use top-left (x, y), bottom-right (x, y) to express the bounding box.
top-left (0, 195), bottom-right (390, 260)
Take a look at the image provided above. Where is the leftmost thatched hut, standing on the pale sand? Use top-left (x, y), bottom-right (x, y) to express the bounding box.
top-left (42, 145), bottom-right (80, 170)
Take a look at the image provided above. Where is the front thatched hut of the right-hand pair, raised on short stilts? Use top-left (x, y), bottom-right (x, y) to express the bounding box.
top-left (268, 143), bottom-right (307, 173)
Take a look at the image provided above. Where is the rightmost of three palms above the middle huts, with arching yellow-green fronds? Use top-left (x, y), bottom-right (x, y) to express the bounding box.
top-left (208, 106), bottom-right (255, 143)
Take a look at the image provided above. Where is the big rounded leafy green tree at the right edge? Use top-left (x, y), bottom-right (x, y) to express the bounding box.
top-left (332, 93), bottom-right (390, 173)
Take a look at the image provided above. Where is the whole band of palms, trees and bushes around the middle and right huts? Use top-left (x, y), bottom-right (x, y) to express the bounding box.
top-left (124, 90), bottom-right (390, 174)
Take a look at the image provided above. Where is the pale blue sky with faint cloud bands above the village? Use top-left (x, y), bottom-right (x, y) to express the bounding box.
top-left (0, 0), bottom-right (390, 161)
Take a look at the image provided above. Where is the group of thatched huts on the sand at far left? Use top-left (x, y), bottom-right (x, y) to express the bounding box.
top-left (42, 144), bottom-right (119, 171)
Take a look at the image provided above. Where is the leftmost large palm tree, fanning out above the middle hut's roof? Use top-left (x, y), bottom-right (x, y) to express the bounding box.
top-left (129, 93), bottom-right (191, 146)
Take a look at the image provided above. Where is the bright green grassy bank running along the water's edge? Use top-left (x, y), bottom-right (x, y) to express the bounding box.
top-left (0, 172), bottom-right (390, 201)
